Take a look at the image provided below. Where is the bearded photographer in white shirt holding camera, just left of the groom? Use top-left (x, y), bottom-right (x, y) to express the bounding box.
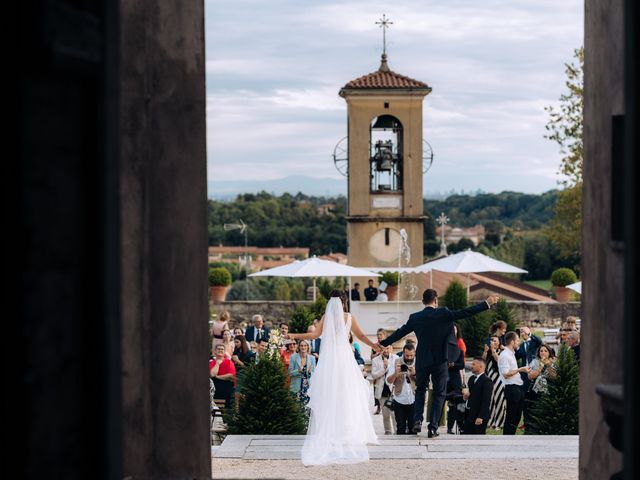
top-left (386, 343), bottom-right (416, 435)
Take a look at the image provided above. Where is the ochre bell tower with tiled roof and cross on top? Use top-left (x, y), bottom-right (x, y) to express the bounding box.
top-left (334, 17), bottom-right (431, 282)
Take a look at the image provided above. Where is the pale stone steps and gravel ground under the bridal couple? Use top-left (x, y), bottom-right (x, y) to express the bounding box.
top-left (211, 415), bottom-right (578, 480)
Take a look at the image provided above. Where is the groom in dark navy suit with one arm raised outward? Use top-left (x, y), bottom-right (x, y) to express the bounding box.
top-left (378, 288), bottom-right (498, 438)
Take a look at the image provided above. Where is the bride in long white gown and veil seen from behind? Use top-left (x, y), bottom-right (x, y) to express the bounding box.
top-left (288, 290), bottom-right (378, 466)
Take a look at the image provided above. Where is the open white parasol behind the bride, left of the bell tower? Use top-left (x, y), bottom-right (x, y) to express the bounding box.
top-left (249, 257), bottom-right (380, 300)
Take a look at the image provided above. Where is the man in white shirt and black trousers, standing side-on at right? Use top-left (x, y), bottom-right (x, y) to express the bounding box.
top-left (498, 332), bottom-right (531, 435)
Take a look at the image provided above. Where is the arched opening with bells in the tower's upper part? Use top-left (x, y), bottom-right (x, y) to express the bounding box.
top-left (369, 115), bottom-right (403, 192)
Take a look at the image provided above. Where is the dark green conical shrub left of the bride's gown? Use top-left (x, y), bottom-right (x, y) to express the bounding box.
top-left (224, 349), bottom-right (307, 435)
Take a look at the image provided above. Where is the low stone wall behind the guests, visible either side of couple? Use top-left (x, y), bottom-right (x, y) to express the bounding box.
top-left (211, 301), bottom-right (581, 328)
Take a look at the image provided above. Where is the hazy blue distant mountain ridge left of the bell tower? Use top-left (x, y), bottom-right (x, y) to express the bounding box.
top-left (207, 175), bottom-right (347, 200)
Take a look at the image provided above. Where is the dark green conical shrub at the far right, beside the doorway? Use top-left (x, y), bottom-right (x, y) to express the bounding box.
top-left (525, 345), bottom-right (580, 435)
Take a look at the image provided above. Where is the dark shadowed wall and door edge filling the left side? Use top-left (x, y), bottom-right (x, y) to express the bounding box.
top-left (10, 0), bottom-right (211, 479)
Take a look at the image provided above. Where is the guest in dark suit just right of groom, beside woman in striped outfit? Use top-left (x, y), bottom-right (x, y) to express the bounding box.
top-left (464, 357), bottom-right (493, 435)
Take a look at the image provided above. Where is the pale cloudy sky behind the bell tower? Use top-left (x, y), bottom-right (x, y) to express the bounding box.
top-left (205, 0), bottom-right (583, 193)
